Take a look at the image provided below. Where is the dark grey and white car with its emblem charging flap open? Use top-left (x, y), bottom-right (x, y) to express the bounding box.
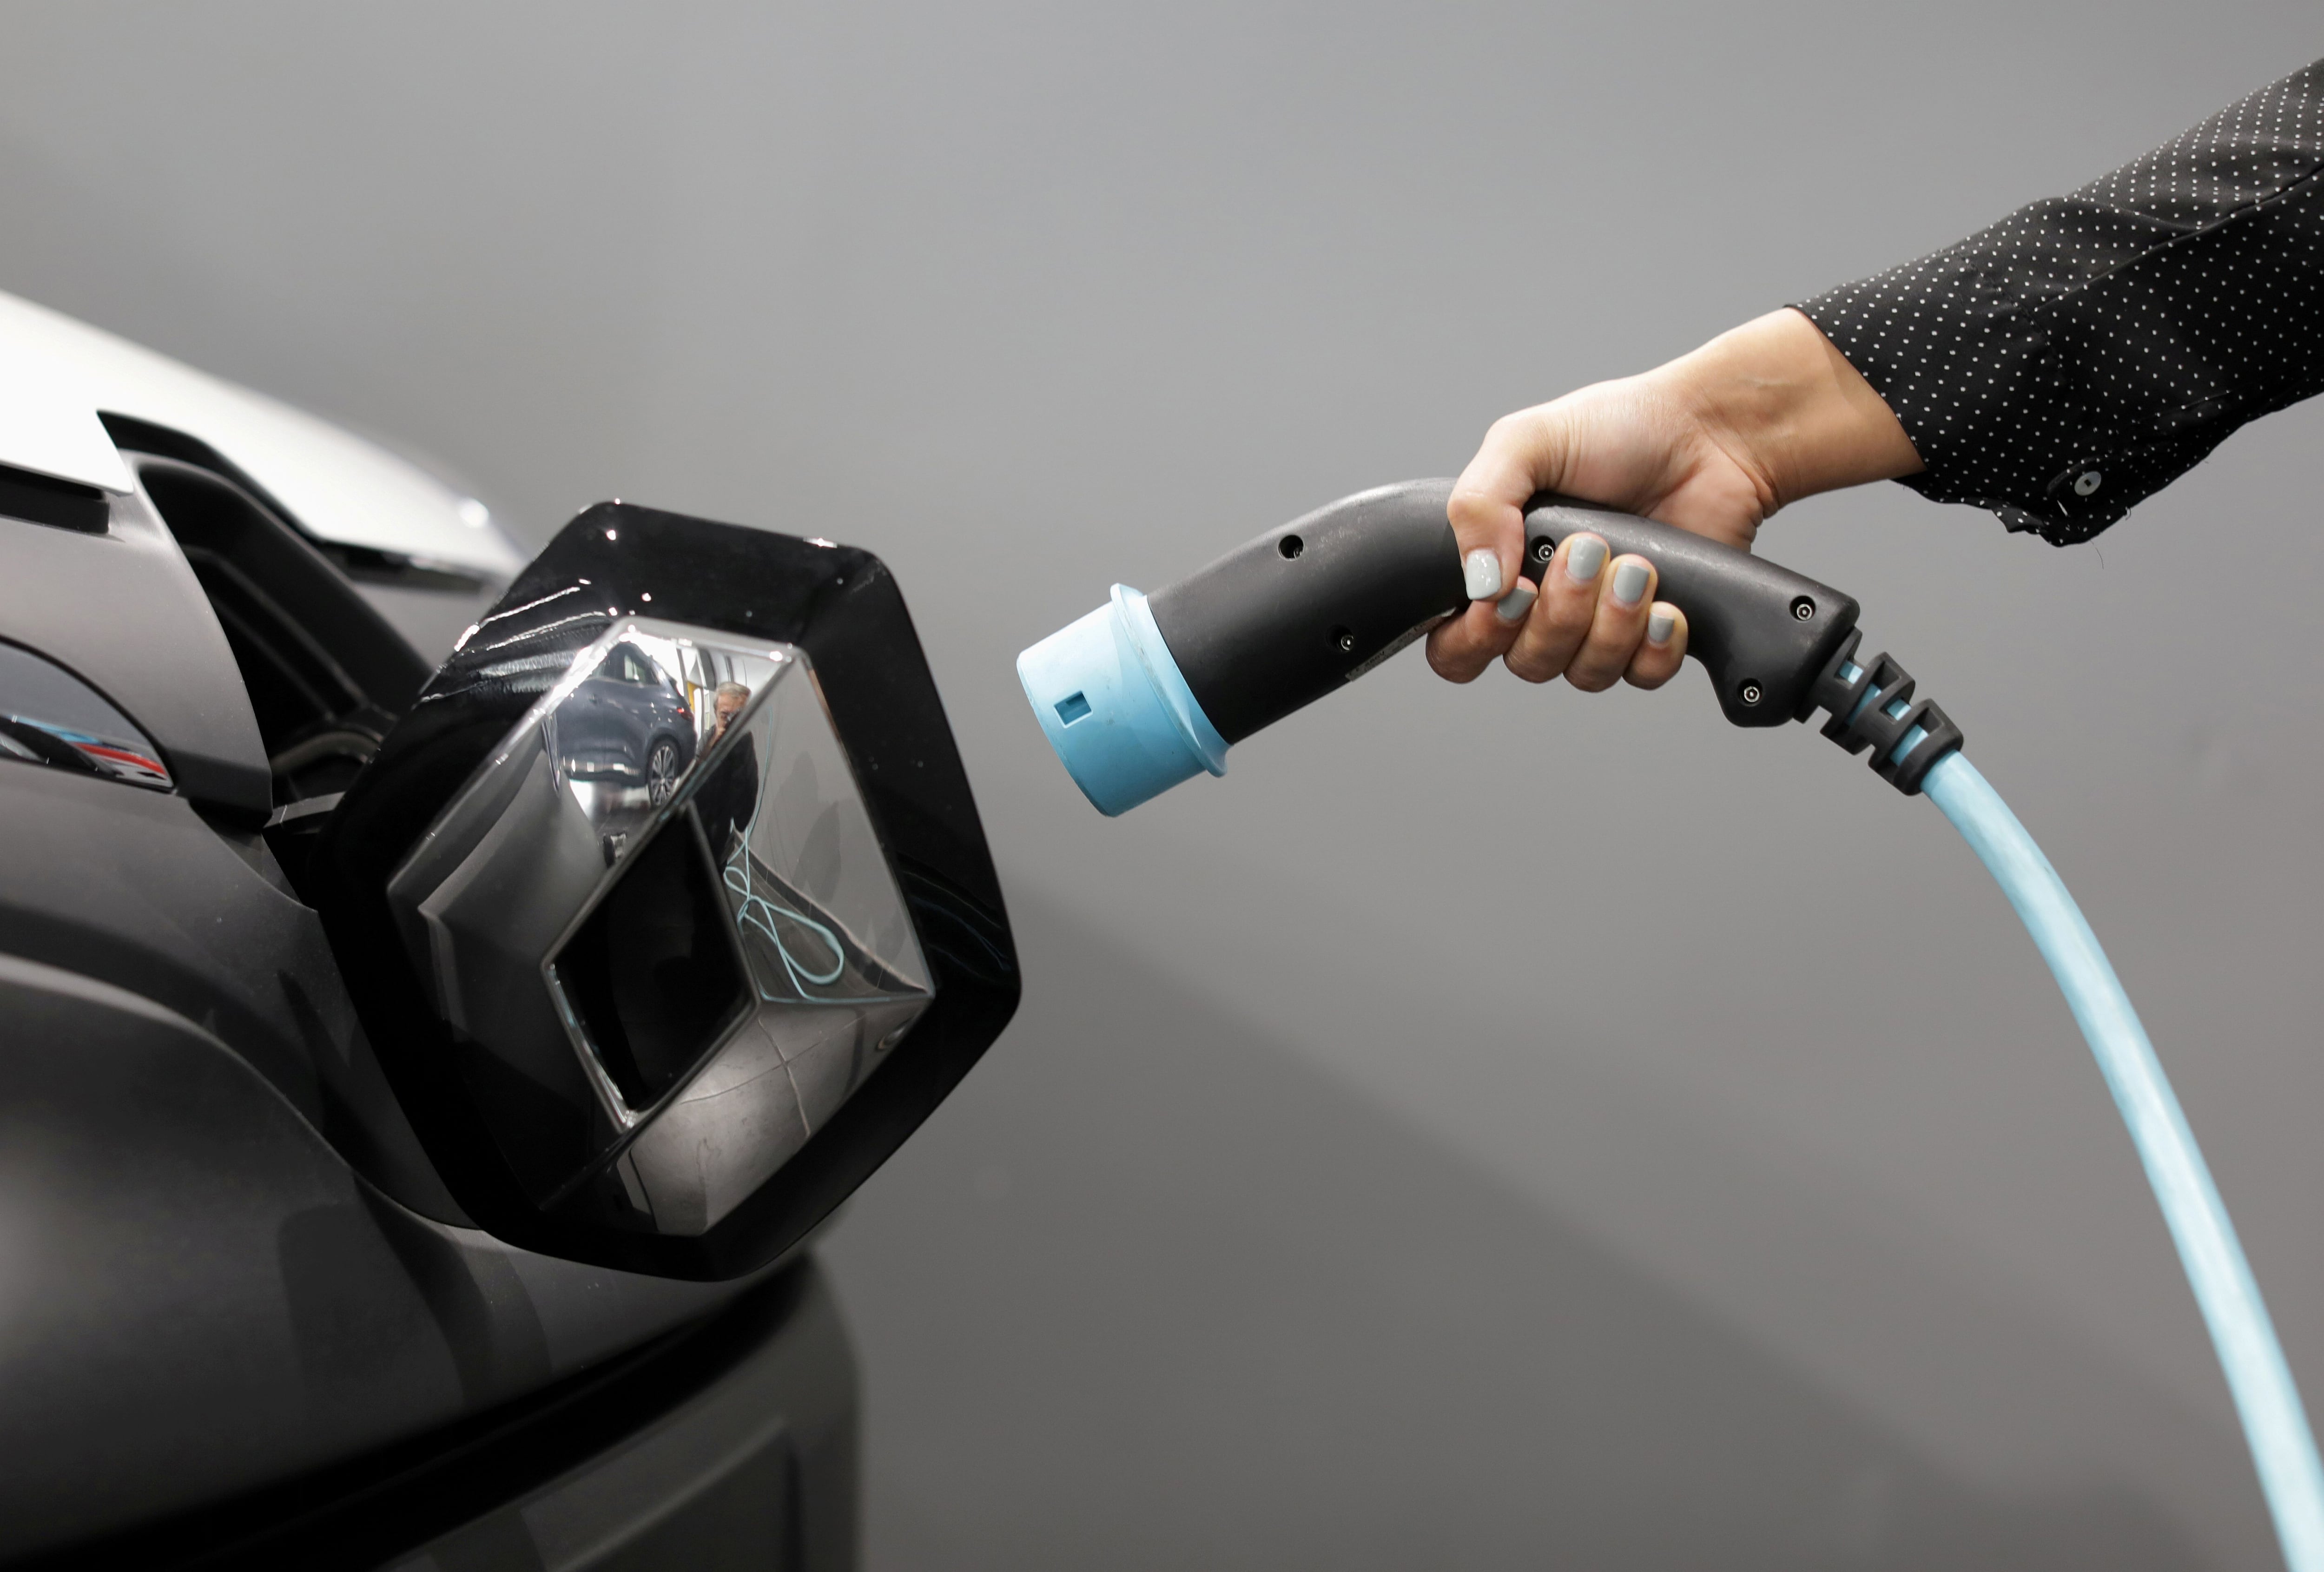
top-left (0, 295), bottom-right (1018, 1570)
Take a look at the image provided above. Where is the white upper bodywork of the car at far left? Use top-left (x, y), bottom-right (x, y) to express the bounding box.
top-left (0, 293), bottom-right (528, 579)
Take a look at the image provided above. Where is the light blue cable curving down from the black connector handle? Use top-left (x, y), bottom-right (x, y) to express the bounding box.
top-left (1924, 753), bottom-right (2324, 1572)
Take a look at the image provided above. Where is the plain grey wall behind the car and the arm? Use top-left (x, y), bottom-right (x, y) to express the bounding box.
top-left (0, 0), bottom-right (2324, 1570)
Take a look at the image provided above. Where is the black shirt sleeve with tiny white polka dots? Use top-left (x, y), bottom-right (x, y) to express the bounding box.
top-left (1799, 60), bottom-right (2324, 547)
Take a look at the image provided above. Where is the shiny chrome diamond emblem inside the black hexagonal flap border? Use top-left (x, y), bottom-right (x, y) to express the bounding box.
top-left (388, 619), bottom-right (934, 1235)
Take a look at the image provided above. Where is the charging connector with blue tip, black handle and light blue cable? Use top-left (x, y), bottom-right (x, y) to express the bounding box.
top-left (1018, 482), bottom-right (2324, 1572)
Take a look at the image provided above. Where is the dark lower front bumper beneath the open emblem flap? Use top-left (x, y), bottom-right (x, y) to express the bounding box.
top-left (7, 1258), bottom-right (858, 1572)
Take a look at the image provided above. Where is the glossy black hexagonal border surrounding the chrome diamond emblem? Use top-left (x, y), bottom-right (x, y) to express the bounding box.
top-left (307, 502), bottom-right (1018, 1279)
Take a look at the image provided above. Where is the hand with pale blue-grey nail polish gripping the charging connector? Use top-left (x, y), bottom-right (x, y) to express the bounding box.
top-left (1429, 311), bottom-right (1920, 693)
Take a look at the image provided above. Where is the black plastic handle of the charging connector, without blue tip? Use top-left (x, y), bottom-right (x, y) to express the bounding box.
top-left (1148, 479), bottom-right (1857, 744)
